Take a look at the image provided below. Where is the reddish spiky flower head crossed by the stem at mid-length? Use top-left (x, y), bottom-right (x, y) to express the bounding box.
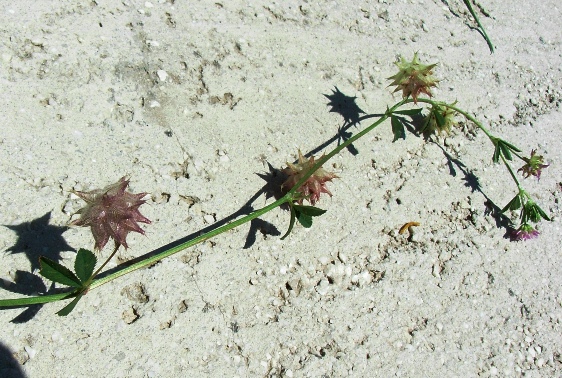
top-left (281, 150), bottom-right (338, 205)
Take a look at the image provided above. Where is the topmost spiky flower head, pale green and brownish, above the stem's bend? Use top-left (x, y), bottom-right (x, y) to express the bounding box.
top-left (387, 53), bottom-right (439, 103)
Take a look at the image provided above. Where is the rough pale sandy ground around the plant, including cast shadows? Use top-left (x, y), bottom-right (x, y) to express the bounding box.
top-left (0, 0), bottom-right (562, 377)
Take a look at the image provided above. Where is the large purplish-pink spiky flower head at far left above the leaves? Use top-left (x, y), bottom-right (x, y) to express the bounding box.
top-left (71, 177), bottom-right (150, 251)
